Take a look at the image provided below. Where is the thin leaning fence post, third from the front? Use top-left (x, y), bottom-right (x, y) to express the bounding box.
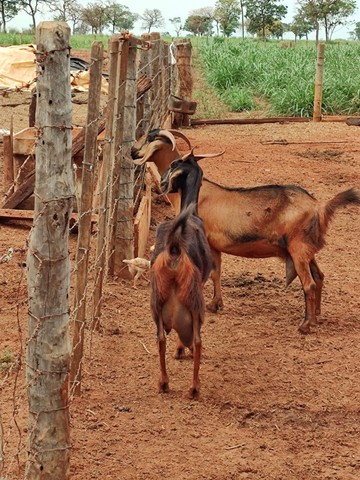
top-left (92, 36), bottom-right (120, 329)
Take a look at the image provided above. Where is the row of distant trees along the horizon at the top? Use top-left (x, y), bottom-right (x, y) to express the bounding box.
top-left (0, 0), bottom-right (360, 41)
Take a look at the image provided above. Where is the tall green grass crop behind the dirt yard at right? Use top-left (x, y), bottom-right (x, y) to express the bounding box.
top-left (199, 39), bottom-right (360, 117)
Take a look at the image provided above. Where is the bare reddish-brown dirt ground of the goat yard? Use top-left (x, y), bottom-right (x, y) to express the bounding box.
top-left (0, 50), bottom-right (360, 480)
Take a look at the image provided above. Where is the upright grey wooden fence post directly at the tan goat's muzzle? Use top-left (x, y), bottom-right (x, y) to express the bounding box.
top-left (114, 40), bottom-right (137, 278)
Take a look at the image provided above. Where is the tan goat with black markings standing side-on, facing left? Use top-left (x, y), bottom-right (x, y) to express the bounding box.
top-left (132, 130), bottom-right (360, 334)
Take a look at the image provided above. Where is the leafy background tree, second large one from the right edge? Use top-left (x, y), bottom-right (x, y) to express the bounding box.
top-left (246, 0), bottom-right (287, 39)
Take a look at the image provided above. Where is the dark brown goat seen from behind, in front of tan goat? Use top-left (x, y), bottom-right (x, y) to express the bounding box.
top-left (150, 156), bottom-right (212, 399)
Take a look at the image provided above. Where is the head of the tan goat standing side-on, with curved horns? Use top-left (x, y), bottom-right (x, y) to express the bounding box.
top-left (131, 129), bottom-right (191, 174)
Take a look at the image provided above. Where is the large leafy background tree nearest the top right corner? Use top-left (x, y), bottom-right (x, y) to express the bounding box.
top-left (298, 0), bottom-right (356, 42)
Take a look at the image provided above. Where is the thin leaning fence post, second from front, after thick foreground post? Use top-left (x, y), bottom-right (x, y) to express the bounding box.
top-left (70, 42), bottom-right (104, 395)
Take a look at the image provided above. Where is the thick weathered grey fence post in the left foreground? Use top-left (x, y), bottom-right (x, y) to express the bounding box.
top-left (25, 22), bottom-right (75, 480)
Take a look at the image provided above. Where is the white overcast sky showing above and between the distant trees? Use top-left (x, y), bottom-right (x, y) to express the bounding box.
top-left (8, 0), bottom-right (360, 39)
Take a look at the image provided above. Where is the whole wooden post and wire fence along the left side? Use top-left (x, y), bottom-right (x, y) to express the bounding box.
top-left (0, 22), bottom-right (193, 480)
